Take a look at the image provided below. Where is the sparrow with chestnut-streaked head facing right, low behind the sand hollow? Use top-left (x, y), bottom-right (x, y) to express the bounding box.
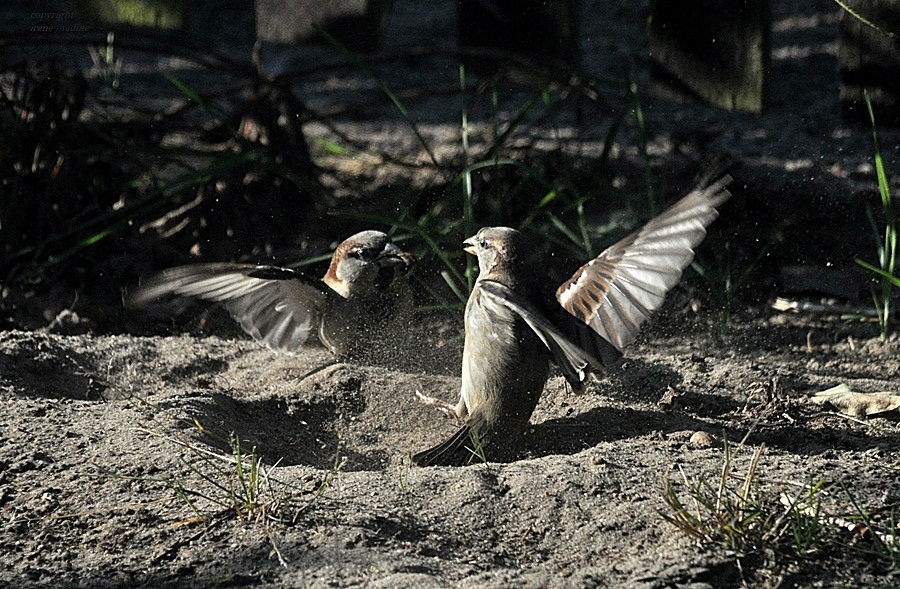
top-left (128, 231), bottom-right (413, 357)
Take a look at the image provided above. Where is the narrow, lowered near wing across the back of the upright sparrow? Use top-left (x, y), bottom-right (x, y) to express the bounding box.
top-left (479, 280), bottom-right (602, 389)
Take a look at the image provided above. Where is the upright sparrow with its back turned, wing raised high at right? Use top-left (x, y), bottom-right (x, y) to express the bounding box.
top-left (412, 176), bottom-right (731, 466)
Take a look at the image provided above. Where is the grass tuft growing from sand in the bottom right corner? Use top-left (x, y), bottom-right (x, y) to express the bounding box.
top-left (662, 434), bottom-right (900, 575)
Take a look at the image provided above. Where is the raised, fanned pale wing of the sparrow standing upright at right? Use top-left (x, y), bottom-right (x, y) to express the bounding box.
top-left (556, 176), bottom-right (731, 351)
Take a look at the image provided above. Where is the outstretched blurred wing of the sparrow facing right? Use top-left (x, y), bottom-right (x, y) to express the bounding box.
top-left (129, 264), bottom-right (340, 352)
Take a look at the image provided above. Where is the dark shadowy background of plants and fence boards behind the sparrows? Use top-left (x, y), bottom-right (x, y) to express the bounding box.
top-left (0, 0), bottom-right (900, 340)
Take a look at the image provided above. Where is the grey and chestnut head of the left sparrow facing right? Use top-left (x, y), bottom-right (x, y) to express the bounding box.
top-left (323, 231), bottom-right (413, 299)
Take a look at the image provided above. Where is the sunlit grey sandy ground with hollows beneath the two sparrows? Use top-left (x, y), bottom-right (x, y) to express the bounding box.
top-left (0, 310), bottom-right (900, 587)
